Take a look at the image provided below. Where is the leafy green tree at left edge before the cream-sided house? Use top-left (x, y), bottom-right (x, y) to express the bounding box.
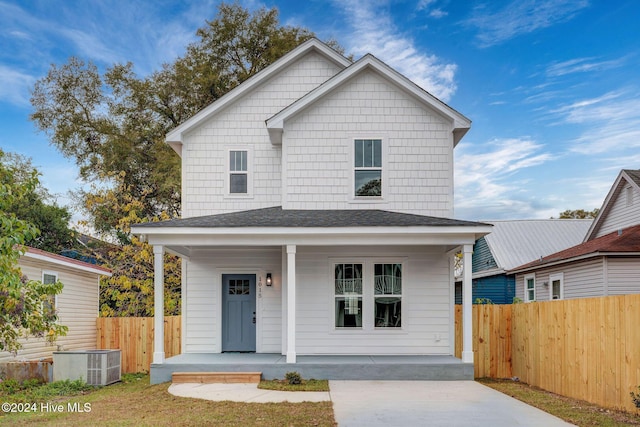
top-left (0, 150), bottom-right (67, 353)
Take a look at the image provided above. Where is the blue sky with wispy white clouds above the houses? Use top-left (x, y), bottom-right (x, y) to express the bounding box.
top-left (0, 0), bottom-right (640, 220)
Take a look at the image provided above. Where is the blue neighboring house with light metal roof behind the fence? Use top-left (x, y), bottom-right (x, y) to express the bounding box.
top-left (455, 219), bottom-right (593, 304)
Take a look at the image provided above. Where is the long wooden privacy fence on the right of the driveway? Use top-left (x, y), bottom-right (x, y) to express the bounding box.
top-left (456, 295), bottom-right (640, 412)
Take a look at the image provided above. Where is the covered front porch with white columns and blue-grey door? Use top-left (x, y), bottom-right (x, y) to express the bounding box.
top-left (134, 207), bottom-right (490, 383)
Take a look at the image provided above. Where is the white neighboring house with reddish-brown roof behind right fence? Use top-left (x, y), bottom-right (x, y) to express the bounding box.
top-left (509, 170), bottom-right (640, 302)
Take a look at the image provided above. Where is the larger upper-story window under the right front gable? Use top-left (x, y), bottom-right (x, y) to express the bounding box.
top-left (354, 139), bottom-right (382, 197)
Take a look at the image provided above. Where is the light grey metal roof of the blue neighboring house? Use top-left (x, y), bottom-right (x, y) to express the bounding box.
top-left (485, 219), bottom-right (593, 270)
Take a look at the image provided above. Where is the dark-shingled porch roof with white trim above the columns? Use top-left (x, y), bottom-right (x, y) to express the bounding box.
top-left (132, 206), bottom-right (492, 257)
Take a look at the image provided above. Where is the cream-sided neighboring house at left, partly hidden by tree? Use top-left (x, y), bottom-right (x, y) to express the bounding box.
top-left (0, 248), bottom-right (111, 362)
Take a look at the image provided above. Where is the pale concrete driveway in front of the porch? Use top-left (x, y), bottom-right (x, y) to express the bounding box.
top-left (329, 381), bottom-right (572, 427)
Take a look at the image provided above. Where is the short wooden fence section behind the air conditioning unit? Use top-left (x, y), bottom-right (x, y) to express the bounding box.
top-left (96, 316), bottom-right (182, 373)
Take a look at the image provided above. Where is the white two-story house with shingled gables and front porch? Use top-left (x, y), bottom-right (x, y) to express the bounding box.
top-left (133, 39), bottom-right (491, 382)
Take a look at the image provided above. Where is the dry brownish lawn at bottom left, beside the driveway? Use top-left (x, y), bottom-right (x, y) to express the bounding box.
top-left (0, 375), bottom-right (336, 427)
